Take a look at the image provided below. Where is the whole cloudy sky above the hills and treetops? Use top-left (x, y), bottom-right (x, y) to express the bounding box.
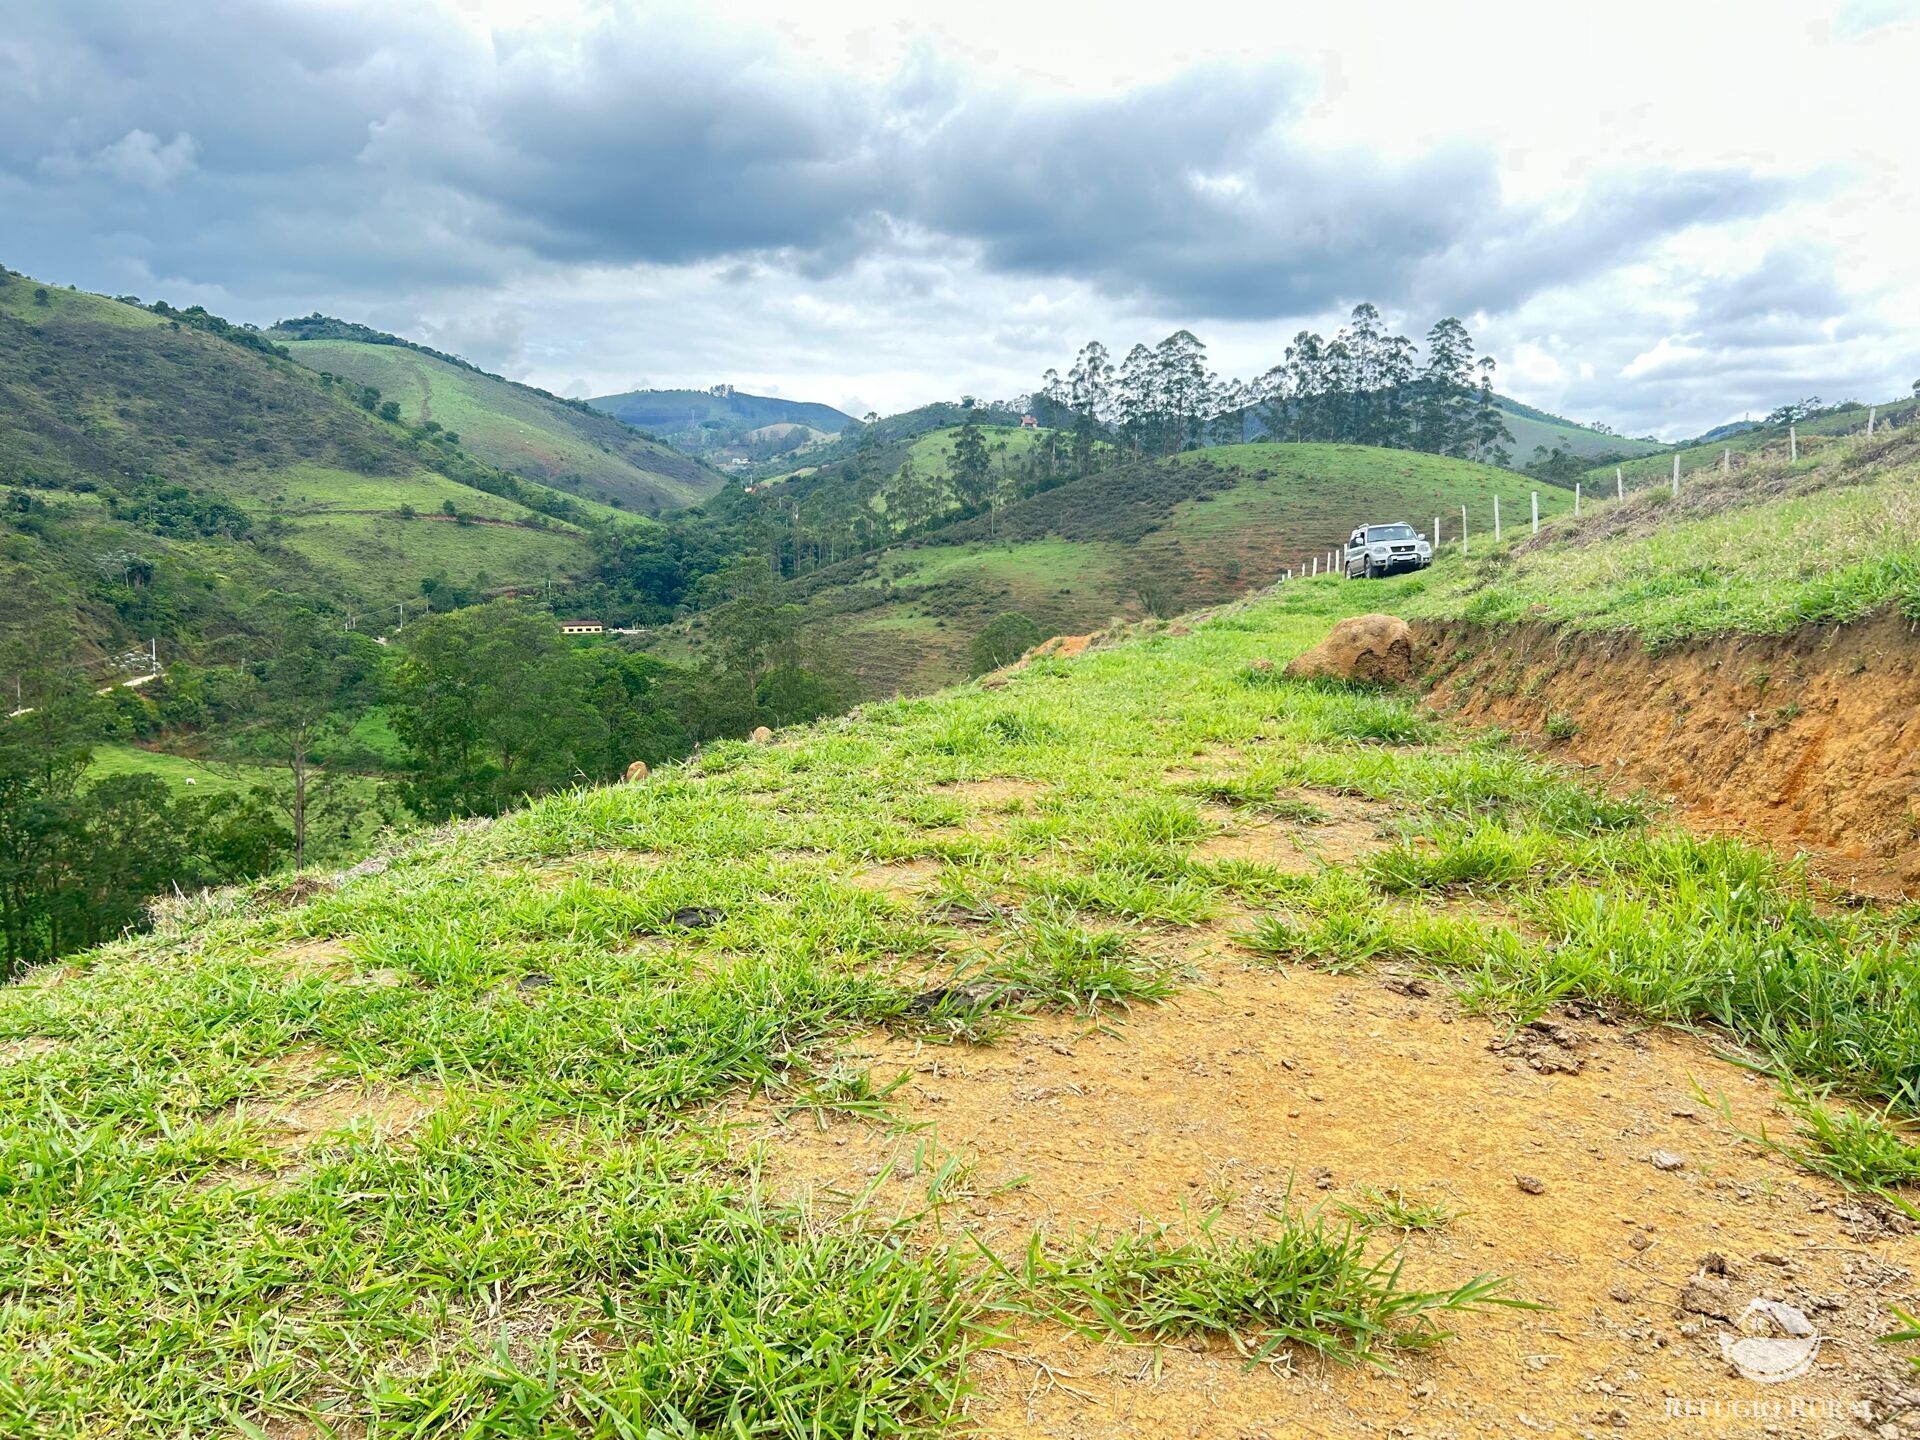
top-left (0, 0), bottom-right (1920, 438)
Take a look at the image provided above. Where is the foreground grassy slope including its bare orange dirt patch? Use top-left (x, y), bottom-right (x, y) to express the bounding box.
top-left (0, 568), bottom-right (1920, 1440)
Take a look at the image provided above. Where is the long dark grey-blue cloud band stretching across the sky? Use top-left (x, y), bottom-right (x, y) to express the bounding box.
top-left (0, 0), bottom-right (1804, 319)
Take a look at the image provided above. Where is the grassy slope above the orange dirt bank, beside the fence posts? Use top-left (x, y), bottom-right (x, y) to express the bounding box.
top-left (1402, 430), bottom-right (1920, 645)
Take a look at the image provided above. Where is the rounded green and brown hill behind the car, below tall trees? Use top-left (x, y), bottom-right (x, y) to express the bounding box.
top-left (741, 443), bottom-right (1572, 693)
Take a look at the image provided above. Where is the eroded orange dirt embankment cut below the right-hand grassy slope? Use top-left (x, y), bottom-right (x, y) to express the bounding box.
top-left (1419, 614), bottom-right (1920, 895)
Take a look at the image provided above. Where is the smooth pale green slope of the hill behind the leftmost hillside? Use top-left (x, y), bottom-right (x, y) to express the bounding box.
top-left (267, 319), bottom-right (720, 511)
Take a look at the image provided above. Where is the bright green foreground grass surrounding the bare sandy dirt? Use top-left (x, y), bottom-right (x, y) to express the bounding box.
top-left (0, 582), bottom-right (1920, 1438)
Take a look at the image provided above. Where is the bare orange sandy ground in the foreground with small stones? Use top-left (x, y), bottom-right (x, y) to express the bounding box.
top-left (735, 906), bottom-right (1920, 1440)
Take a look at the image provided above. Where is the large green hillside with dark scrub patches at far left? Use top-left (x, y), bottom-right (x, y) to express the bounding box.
top-left (0, 275), bottom-right (641, 655)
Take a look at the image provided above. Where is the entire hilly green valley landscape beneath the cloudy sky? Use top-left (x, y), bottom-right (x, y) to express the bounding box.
top-left (0, 276), bottom-right (1920, 1440)
